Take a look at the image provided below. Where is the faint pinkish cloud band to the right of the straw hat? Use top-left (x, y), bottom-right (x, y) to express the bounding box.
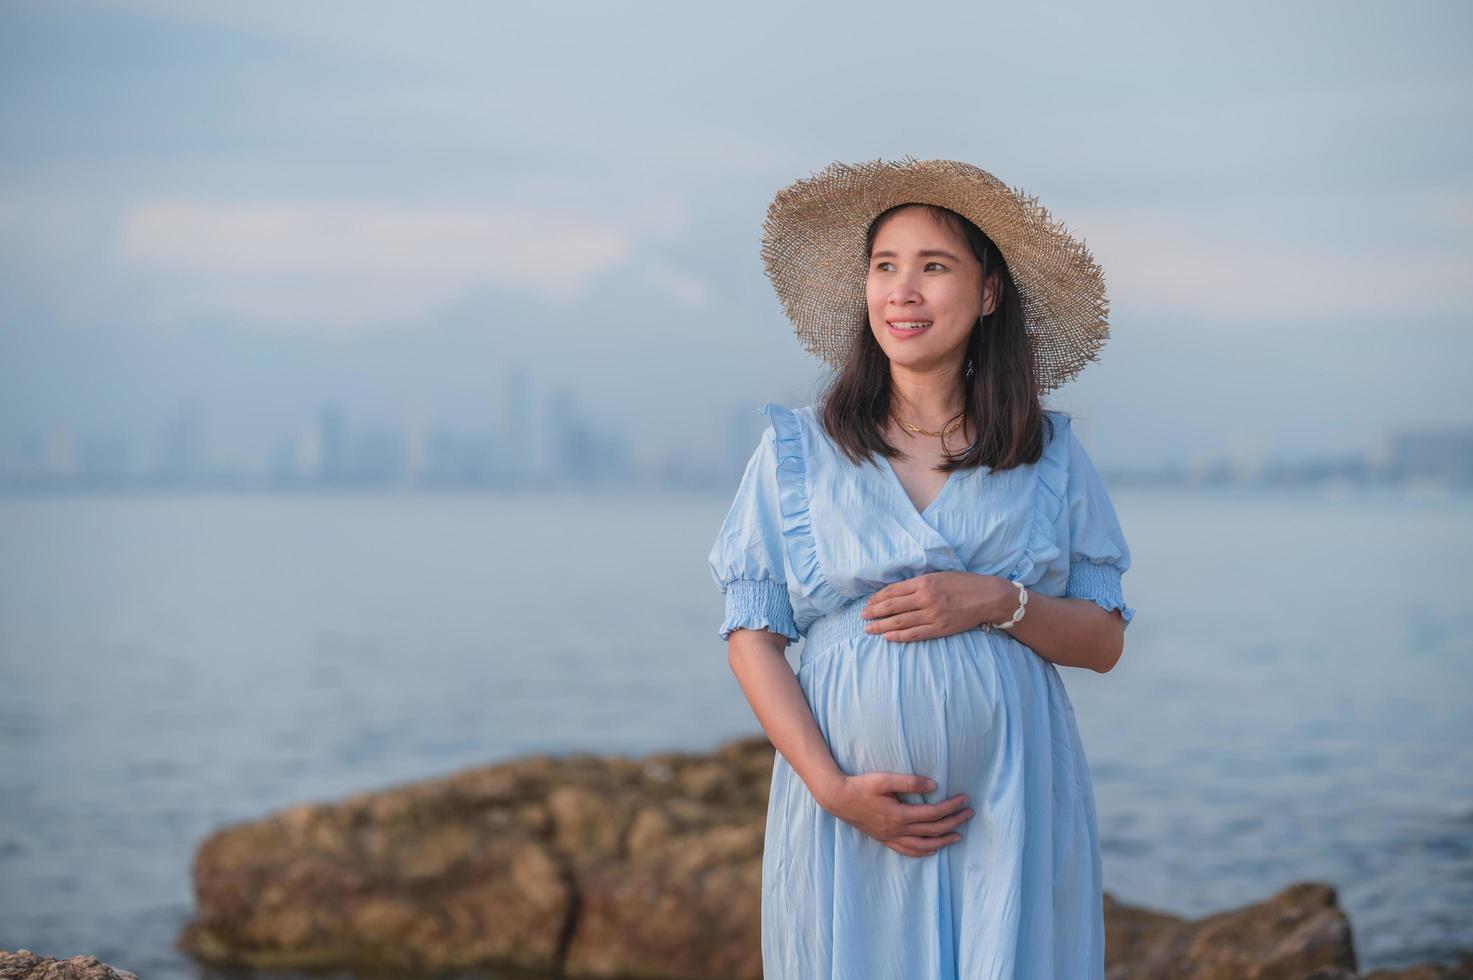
top-left (1069, 190), bottom-right (1473, 326)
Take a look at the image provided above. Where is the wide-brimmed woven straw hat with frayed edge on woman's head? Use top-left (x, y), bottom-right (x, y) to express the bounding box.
top-left (762, 156), bottom-right (1109, 391)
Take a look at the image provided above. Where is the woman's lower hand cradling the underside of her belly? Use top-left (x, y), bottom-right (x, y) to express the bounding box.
top-left (819, 772), bottom-right (974, 858)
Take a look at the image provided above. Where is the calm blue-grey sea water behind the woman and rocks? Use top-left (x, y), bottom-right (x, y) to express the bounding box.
top-left (0, 491), bottom-right (1473, 977)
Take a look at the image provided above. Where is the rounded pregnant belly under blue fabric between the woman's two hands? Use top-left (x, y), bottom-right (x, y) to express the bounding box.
top-left (798, 613), bottom-right (1015, 803)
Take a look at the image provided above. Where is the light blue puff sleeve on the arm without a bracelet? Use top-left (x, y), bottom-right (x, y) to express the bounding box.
top-left (709, 427), bottom-right (798, 643)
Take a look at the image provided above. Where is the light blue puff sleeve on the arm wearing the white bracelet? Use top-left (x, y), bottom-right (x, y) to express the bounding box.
top-left (1064, 426), bottom-right (1136, 626)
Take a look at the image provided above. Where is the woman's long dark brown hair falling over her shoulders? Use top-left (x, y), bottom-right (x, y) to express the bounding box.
top-left (819, 205), bottom-right (1053, 473)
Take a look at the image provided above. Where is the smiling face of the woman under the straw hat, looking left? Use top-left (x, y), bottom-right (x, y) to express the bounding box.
top-left (865, 206), bottom-right (994, 370)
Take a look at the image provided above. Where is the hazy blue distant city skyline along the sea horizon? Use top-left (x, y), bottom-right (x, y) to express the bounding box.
top-left (0, 368), bottom-right (1473, 492)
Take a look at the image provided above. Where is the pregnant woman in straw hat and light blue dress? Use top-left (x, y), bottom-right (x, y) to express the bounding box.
top-left (710, 158), bottom-right (1134, 980)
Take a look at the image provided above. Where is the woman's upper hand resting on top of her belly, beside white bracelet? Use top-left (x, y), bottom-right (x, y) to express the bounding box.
top-left (860, 572), bottom-right (1018, 643)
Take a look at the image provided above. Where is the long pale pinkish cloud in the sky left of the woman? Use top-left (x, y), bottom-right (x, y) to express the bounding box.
top-left (115, 200), bottom-right (633, 329)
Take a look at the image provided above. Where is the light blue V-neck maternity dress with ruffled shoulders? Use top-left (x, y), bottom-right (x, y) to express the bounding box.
top-left (710, 402), bottom-right (1134, 980)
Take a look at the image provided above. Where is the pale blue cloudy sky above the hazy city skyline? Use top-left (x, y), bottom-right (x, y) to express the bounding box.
top-left (0, 0), bottom-right (1473, 466)
